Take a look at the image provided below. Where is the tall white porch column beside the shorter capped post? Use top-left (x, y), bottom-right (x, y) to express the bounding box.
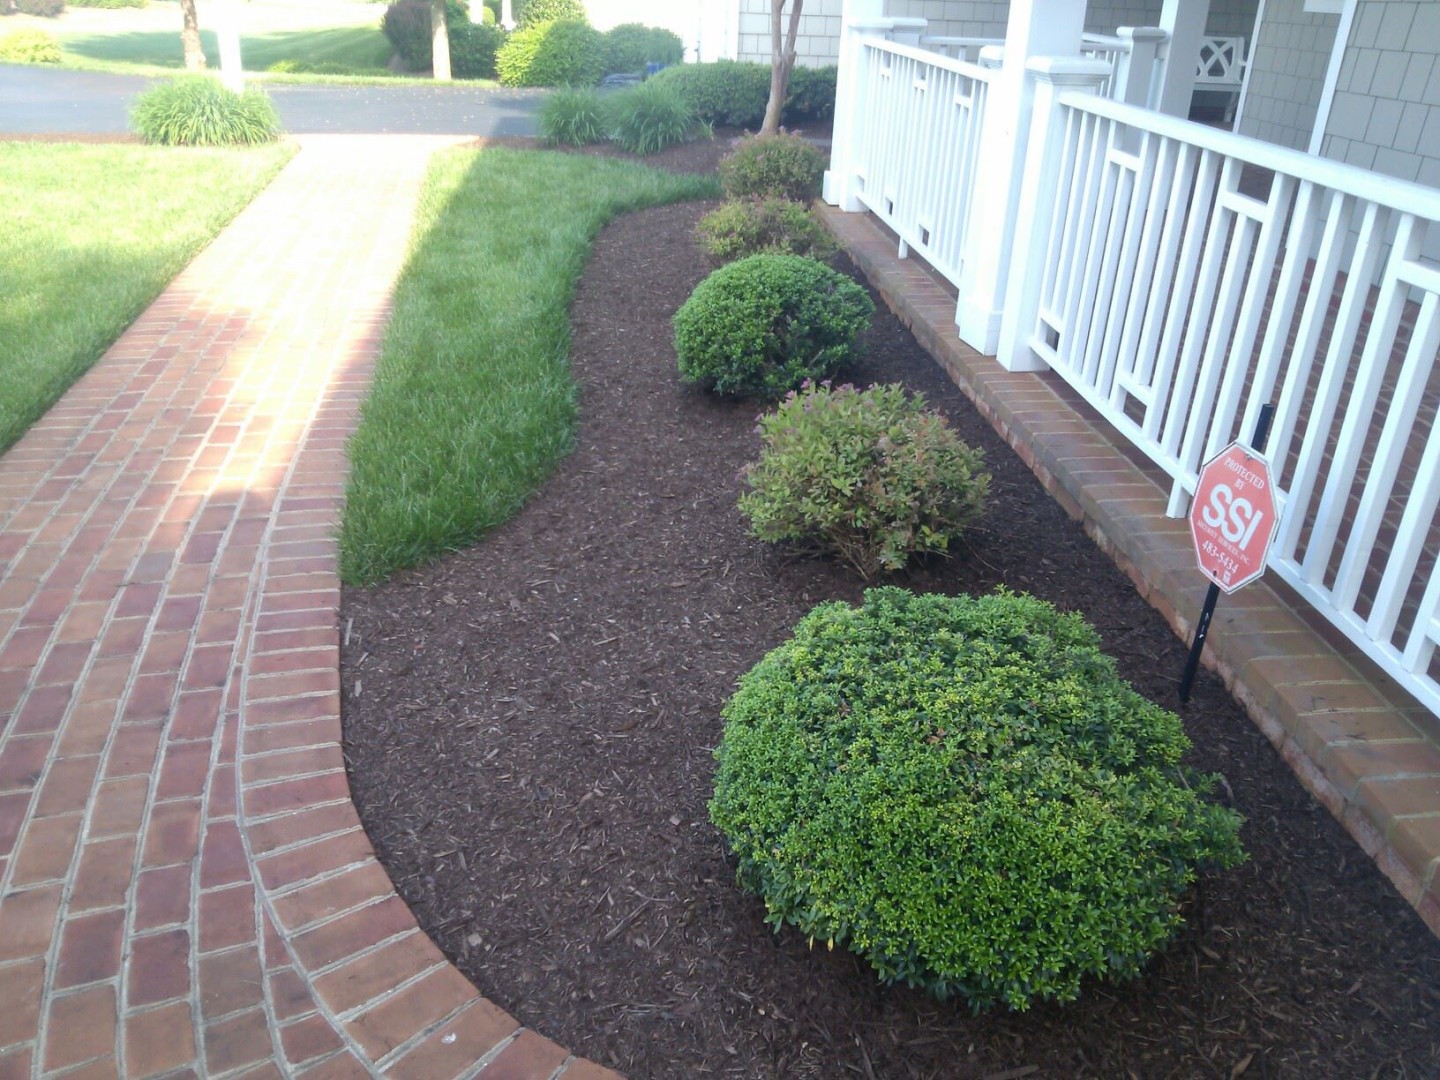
top-left (955, 0), bottom-right (1086, 356)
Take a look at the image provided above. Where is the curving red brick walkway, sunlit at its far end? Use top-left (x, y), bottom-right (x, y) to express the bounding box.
top-left (0, 137), bottom-right (613, 1080)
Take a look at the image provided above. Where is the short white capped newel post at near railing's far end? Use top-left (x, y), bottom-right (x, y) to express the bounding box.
top-left (994, 56), bottom-right (1110, 372)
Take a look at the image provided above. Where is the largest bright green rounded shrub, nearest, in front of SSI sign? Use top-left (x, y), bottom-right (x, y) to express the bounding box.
top-left (710, 588), bottom-right (1244, 1011)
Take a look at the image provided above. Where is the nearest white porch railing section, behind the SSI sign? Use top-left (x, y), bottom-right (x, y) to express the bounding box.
top-left (1007, 88), bottom-right (1440, 711)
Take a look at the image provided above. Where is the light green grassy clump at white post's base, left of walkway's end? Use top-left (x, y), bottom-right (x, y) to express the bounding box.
top-left (130, 75), bottom-right (281, 147)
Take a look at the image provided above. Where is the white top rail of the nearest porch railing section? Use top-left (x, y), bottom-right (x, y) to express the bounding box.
top-left (1060, 94), bottom-right (1440, 220)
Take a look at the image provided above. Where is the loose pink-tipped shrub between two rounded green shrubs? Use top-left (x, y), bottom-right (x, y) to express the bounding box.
top-left (740, 384), bottom-right (989, 577)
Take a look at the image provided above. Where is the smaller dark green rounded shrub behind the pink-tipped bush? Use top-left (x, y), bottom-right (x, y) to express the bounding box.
top-left (674, 255), bottom-right (876, 399)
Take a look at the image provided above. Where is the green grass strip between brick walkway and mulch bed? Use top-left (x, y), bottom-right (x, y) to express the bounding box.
top-left (340, 150), bottom-right (719, 585)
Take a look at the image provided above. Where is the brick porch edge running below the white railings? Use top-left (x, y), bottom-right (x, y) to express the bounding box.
top-left (821, 206), bottom-right (1440, 935)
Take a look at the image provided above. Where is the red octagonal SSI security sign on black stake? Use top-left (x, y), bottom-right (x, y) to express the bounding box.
top-left (1189, 442), bottom-right (1279, 593)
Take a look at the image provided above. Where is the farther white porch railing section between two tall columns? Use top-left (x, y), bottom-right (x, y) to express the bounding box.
top-left (847, 39), bottom-right (995, 288)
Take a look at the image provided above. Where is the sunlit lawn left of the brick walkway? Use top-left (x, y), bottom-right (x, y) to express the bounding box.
top-left (0, 143), bottom-right (294, 451)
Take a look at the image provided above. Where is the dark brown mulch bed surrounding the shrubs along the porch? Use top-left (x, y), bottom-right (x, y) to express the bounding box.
top-left (343, 139), bottom-right (1440, 1079)
